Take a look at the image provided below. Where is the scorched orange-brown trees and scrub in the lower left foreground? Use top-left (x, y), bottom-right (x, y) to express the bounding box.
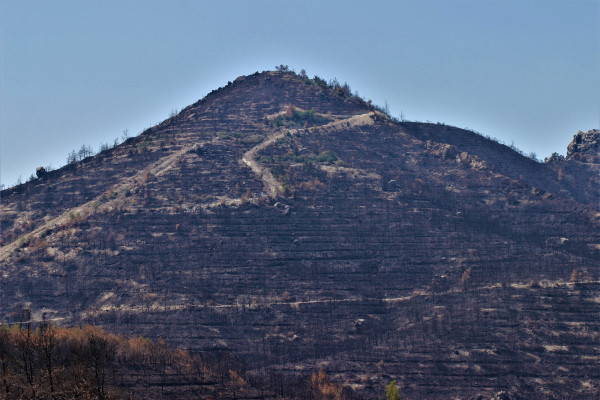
top-left (0, 321), bottom-right (314, 400)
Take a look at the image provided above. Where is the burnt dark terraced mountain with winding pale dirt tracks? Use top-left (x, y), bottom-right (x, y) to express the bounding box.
top-left (0, 71), bottom-right (600, 399)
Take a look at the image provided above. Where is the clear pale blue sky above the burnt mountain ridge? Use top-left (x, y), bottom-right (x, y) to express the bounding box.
top-left (0, 0), bottom-right (600, 186)
